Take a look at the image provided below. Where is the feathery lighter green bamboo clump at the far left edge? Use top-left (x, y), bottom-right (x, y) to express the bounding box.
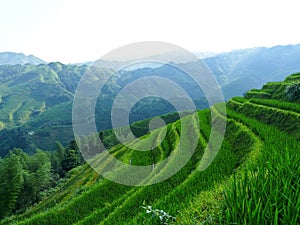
top-left (0, 149), bottom-right (51, 218)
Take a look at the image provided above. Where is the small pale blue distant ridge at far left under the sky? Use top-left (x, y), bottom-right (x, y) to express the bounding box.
top-left (0, 52), bottom-right (46, 65)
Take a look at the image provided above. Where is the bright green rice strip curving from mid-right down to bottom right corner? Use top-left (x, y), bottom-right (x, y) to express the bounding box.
top-left (225, 108), bottom-right (300, 225)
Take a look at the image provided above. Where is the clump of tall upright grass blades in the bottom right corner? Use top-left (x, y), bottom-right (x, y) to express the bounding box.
top-left (225, 148), bottom-right (300, 224)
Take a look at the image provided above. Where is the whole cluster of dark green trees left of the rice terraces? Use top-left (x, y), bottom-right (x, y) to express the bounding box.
top-left (0, 141), bottom-right (84, 219)
